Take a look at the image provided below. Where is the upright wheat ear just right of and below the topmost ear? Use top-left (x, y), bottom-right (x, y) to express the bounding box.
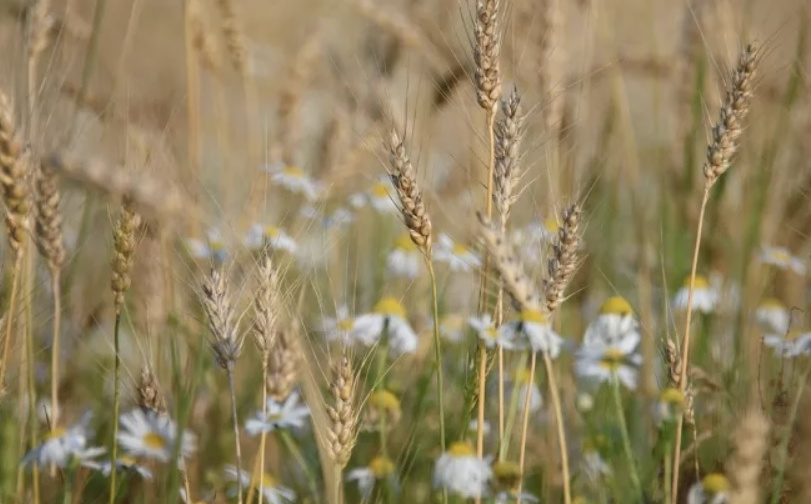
top-left (493, 89), bottom-right (524, 231)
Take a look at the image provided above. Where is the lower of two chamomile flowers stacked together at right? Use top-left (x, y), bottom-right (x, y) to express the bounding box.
top-left (575, 334), bottom-right (642, 390)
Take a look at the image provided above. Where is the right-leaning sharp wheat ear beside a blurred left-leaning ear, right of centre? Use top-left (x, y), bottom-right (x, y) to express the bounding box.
top-left (543, 204), bottom-right (581, 313)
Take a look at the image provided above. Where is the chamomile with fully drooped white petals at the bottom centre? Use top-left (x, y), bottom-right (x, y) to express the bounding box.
top-left (434, 442), bottom-right (493, 498)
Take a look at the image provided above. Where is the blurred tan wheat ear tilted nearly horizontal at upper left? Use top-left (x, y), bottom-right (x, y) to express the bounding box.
top-left (48, 155), bottom-right (189, 217)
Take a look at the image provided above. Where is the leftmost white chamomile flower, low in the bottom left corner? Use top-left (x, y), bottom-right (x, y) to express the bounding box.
top-left (22, 414), bottom-right (105, 467)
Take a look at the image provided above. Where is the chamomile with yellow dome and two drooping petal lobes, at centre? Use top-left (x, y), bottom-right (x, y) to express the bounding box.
top-left (350, 297), bottom-right (418, 356)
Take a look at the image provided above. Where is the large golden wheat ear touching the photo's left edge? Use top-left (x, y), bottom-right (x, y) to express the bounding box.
top-left (0, 91), bottom-right (29, 256)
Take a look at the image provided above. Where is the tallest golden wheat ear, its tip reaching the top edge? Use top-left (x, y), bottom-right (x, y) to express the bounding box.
top-left (473, 0), bottom-right (501, 112)
